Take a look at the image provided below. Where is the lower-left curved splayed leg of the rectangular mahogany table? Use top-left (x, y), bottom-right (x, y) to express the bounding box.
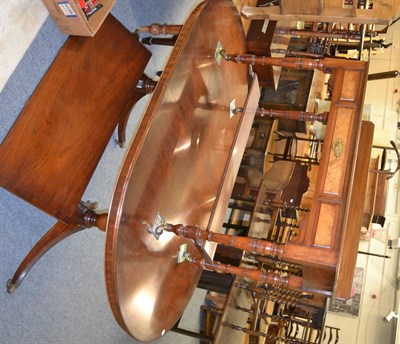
top-left (7, 221), bottom-right (85, 294)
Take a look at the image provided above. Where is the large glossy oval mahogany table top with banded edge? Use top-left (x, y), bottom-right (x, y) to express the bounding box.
top-left (105, 0), bottom-right (259, 341)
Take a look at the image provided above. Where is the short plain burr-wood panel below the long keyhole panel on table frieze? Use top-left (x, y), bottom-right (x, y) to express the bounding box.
top-left (314, 203), bottom-right (340, 247)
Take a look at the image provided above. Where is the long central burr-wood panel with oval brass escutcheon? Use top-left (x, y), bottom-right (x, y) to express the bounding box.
top-left (324, 108), bottom-right (354, 196)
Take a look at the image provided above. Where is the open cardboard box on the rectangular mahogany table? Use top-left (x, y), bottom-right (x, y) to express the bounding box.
top-left (43, 0), bottom-right (115, 36)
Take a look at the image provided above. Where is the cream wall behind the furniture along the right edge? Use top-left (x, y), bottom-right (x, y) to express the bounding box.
top-left (326, 21), bottom-right (400, 344)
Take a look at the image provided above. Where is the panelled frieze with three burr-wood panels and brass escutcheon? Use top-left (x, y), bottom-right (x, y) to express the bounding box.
top-left (294, 59), bottom-right (371, 296)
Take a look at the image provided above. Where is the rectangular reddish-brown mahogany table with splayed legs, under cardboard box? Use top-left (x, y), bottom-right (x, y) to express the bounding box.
top-left (0, 15), bottom-right (154, 292)
